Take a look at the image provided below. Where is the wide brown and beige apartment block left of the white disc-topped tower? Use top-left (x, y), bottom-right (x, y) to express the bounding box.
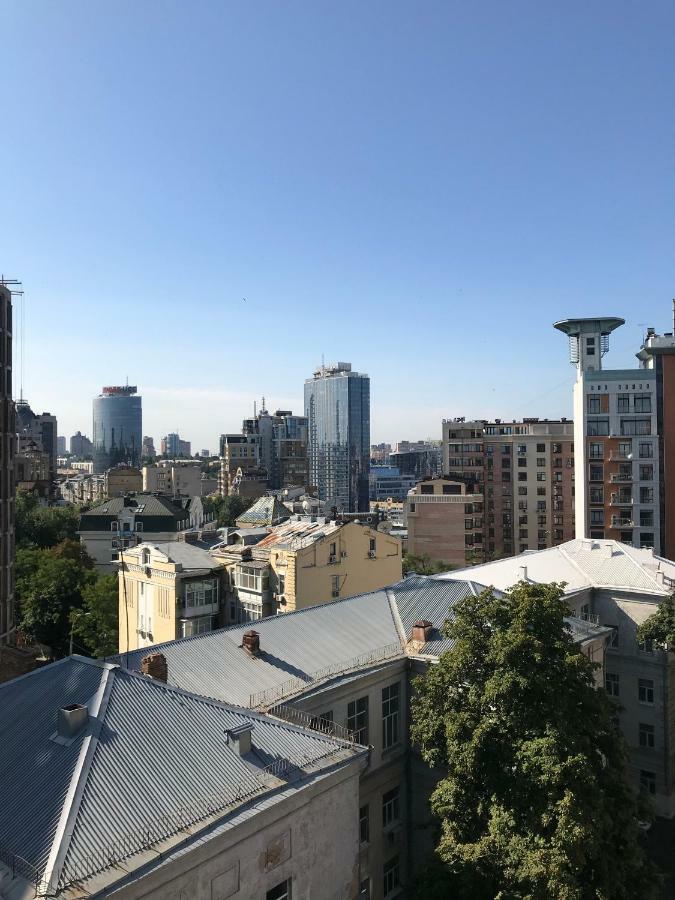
top-left (443, 418), bottom-right (575, 559)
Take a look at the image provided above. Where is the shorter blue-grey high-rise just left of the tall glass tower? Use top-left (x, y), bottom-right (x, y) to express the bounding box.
top-left (242, 397), bottom-right (309, 490)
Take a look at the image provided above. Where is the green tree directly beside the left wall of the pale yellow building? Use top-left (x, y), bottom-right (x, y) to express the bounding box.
top-left (70, 575), bottom-right (119, 657)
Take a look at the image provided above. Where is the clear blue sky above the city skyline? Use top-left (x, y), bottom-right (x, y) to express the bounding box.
top-left (0, 0), bottom-right (675, 449)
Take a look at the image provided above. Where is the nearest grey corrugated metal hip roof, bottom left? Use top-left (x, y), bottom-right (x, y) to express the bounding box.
top-left (0, 657), bottom-right (365, 896)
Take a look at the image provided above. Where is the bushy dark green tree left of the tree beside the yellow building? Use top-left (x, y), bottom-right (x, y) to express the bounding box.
top-left (16, 549), bottom-right (90, 656)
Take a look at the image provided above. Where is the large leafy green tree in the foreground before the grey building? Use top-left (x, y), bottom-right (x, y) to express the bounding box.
top-left (412, 584), bottom-right (657, 900)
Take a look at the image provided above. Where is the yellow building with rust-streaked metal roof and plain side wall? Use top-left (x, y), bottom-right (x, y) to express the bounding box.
top-left (212, 515), bottom-right (402, 622)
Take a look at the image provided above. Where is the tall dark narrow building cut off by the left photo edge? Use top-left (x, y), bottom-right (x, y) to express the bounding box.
top-left (0, 283), bottom-right (16, 646)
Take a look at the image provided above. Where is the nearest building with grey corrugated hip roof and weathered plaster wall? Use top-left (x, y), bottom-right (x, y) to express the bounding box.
top-left (0, 651), bottom-right (369, 900)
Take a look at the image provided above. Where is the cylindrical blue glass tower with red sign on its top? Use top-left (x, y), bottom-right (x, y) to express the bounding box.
top-left (93, 384), bottom-right (143, 474)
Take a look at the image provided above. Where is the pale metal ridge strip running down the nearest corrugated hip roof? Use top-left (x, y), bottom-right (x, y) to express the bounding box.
top-left (43, 666), bottom-right (118, 892)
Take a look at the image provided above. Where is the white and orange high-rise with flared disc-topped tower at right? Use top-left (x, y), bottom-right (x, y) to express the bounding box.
top-left (555, 317), bottom-right (675, 558)
